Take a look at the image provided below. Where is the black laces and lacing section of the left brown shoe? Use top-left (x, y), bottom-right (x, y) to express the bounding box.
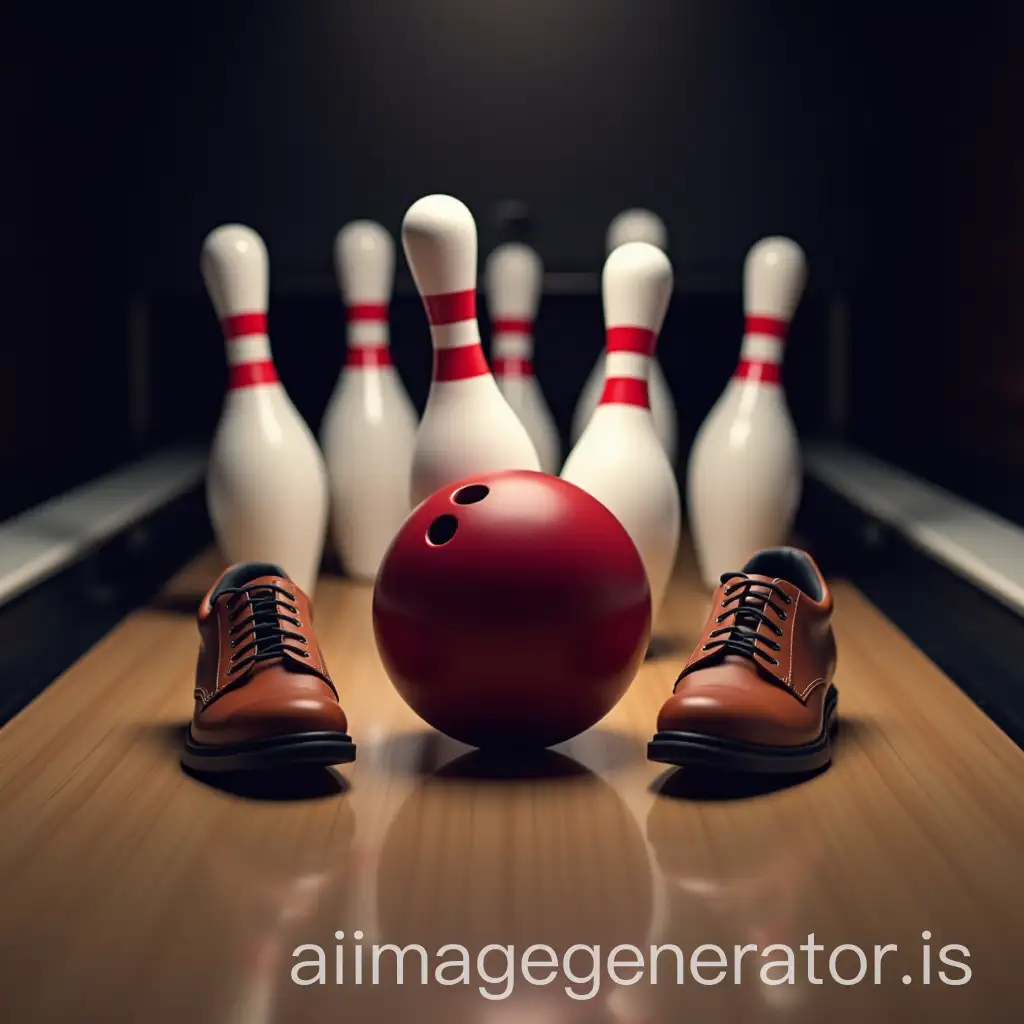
top-left (220, 583), bottom-right (309, 676)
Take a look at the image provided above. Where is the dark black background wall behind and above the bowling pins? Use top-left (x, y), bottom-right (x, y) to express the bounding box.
top-left (0, 0), bottom-right (1024, 517)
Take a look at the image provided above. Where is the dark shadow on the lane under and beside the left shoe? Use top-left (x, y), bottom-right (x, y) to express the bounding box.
top-left (140, 722), bottom-right (348, 803)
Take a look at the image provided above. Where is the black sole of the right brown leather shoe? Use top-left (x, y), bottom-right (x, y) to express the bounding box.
top-left (647, 686), bottom-right (839, 775)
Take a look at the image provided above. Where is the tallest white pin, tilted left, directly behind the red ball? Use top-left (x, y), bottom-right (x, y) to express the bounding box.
top-left (401, 196), bottom-right (541, 505)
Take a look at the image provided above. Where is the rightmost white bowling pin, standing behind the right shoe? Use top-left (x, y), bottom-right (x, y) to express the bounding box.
top-left (687, 238), bottom-right (807, 589)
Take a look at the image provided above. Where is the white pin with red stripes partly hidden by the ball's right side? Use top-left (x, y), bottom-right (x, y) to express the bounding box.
top-left (561, 242), bottom-right (681, 616)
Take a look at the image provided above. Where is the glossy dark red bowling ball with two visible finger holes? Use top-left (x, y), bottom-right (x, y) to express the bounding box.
top-left (373, 471), bottom-right (651, 748)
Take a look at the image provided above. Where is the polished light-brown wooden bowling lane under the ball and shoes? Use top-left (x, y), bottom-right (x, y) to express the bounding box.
top-left (0, 558), bottom-right (1024, 1024)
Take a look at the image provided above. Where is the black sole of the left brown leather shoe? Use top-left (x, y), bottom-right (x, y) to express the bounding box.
top-left (181, 732), bottom-right (355, 773)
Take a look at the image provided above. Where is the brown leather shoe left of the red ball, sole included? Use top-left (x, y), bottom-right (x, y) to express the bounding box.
top-left (181, 562), bottom-right (355, 772)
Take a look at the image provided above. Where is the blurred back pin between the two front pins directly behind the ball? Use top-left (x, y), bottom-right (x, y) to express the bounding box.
top-left (484, 242), bottom-right (561, 474)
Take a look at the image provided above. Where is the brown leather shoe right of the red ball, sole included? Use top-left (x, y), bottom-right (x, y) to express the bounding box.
top-left (647, 548), bottom-right (839, 772)
